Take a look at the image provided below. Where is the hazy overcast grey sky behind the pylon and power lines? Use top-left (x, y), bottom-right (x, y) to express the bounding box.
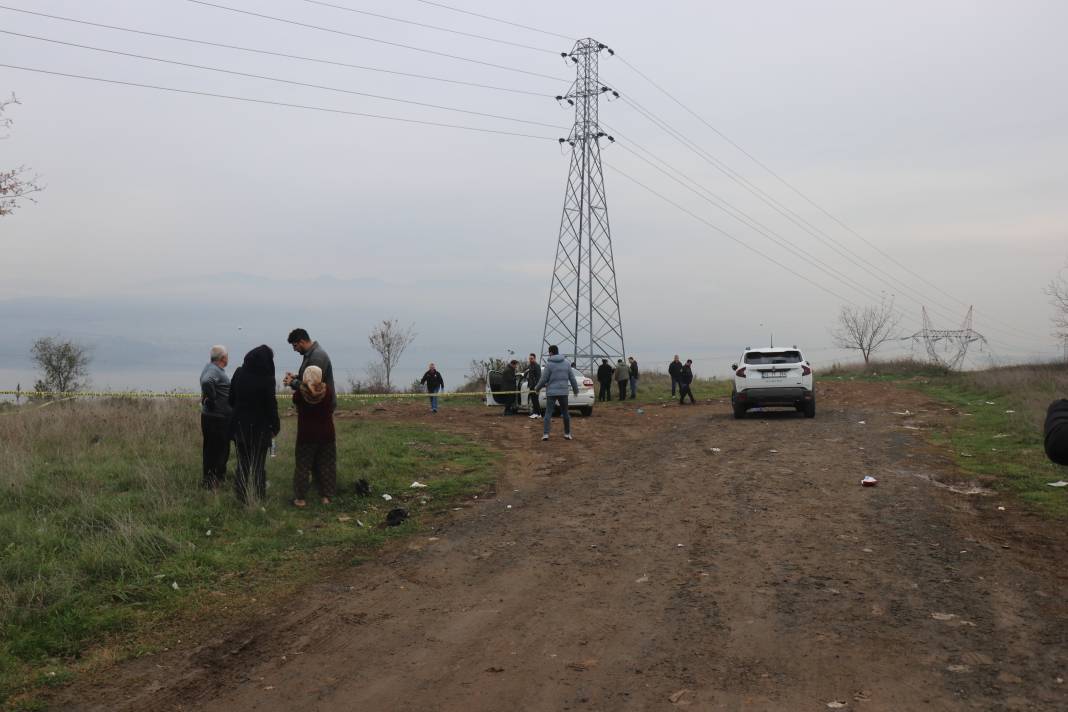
top-left (0, 0), bottom-right (1068, 389)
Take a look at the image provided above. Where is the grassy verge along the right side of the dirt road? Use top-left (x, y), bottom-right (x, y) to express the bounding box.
top-left (826, 361), bottom-right (1068, 519)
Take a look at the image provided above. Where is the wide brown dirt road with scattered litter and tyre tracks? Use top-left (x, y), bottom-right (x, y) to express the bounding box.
top-left (61, 384), bottom-right (1068, 712)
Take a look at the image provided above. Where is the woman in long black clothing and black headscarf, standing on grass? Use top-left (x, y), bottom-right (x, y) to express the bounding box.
top-left (230, 345), bottom-right (279, 504)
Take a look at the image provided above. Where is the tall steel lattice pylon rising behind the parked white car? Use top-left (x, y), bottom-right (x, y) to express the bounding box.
top-left (541, 38), bottom-right (626, 375)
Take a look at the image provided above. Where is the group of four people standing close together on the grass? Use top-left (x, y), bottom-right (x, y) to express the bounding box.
top-left (200, 329), bottom-right (337, 507)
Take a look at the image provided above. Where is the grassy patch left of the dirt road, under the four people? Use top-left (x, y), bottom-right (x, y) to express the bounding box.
top-left (0, 401), bottom-right (497, 702)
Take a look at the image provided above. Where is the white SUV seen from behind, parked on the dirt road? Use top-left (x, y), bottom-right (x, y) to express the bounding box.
top-left (731, 346), bottom-right (816, 417)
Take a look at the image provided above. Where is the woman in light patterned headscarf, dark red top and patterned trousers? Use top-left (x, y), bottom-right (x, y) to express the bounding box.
top-left (293, 366), bottom-right (337, 507)
